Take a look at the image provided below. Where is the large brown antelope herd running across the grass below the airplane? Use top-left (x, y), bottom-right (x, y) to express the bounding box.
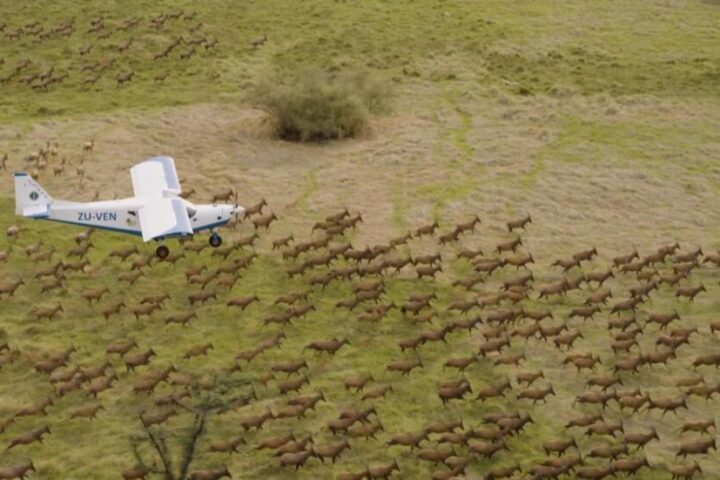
top-left (0, 182), bottom-right (720, 479)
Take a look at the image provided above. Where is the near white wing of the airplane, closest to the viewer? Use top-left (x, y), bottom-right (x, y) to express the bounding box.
top-left (138, 194), bottom-right (193, 242)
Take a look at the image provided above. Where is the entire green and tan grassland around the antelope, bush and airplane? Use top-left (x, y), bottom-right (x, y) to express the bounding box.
top-left (0, 0), bottom-right (720, 479)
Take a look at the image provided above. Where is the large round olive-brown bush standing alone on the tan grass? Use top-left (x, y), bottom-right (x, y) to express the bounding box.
top-left (253, 68), bottom-right (389, 142)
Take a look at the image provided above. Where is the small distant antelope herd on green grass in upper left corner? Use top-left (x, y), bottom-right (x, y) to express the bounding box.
top-left (0, 9), bottom-right (250, 92)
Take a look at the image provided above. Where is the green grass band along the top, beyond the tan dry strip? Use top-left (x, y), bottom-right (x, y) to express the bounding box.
top-left (0, 0), bottom-right (720, 121)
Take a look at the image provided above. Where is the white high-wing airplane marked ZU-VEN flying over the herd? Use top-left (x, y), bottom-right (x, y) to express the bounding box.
top-left (14, 157), bottom-right (245, 258)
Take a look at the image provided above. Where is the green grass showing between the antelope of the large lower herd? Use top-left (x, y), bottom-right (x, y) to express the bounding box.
top-left (0, 196), bottom-right (717, 479)
